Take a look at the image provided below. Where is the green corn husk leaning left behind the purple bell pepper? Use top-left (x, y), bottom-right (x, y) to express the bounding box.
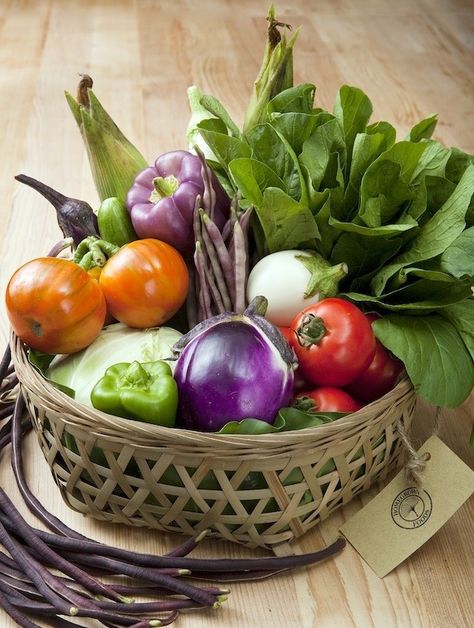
top-left (65, 75), bottom-right (148, 201)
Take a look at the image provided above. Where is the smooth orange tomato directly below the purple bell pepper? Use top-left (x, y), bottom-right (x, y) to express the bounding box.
top-left (99, 238), bottom-right (189, 328)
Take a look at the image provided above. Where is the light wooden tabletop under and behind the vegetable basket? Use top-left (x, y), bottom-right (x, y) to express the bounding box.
top-left (0, 0), bottom-right (474, 628)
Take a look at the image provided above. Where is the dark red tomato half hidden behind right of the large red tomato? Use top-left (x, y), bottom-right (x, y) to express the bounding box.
top-left (346, 313), bottom-right (403, 401)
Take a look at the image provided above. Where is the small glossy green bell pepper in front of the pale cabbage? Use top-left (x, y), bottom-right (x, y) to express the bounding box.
top-left (91, 360), bottom-right (178, 427)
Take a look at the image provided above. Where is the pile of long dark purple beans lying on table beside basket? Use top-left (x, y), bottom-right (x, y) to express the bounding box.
top-left (0, 348), bottom-right (345, 628)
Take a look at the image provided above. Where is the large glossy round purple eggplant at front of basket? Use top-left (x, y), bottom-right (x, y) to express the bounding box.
top-left (170, 297), bottom-right (296, 432)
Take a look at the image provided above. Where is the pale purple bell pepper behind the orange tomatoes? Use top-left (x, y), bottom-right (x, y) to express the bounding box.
top-left (127, 150), bottom-right (229, 254)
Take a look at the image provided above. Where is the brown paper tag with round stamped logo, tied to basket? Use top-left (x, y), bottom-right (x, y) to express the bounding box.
top-left (341, 436), bottom-right (474, 578)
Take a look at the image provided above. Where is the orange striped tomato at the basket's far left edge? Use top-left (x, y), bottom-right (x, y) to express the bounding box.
top-left (5, 257), bottom-right (106, 353)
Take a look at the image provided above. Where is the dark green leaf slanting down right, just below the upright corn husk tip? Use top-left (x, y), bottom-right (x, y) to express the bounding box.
top-left (246, 123), bottom-right (302, 200)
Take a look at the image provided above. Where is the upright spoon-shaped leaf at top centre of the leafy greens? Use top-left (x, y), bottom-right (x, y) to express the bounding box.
top-left (334, 85), bottom-right (372, 168)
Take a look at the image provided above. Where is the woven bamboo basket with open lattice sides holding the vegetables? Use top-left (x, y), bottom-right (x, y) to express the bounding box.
top-left (11, 335), bottom-right (415, 550)
